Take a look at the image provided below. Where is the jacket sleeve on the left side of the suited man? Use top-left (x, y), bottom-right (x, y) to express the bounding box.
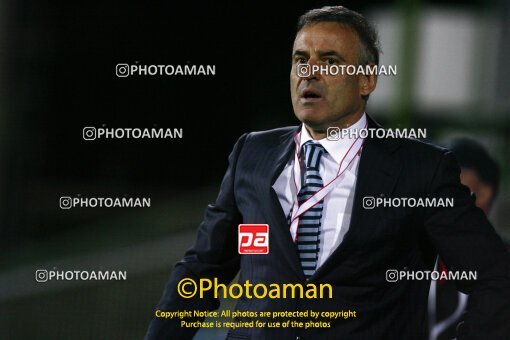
top-left (145, 134), bottom-right (246, 340)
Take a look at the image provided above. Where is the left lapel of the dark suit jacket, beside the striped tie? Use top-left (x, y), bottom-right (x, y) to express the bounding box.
top-left (259, 127), bottom-right (304, 279)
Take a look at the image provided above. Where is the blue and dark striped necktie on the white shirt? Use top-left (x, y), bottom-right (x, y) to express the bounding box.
top-left (297, 141), bottom-right (326, 279)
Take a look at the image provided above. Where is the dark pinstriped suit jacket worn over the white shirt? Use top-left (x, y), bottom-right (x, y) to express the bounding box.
top-left (146, 118), bottom-right (510, 340)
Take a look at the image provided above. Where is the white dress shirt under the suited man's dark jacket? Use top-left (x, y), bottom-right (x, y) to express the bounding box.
top-left (273, 114), bottom-right (367, 268)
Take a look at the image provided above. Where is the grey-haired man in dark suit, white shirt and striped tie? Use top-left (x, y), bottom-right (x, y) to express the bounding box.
top-left (146, 6), bottom-right (510, 340)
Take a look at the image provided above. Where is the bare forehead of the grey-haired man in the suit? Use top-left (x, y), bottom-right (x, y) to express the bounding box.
top-left (294, 22), bottom-right (358, 50)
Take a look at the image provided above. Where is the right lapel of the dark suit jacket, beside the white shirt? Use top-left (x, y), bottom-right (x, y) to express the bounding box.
top-left (311, 115), bottom-right (402, 280)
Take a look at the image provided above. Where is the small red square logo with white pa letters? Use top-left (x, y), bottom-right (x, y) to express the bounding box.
top-left (238, 224), bottom-right (269, 255)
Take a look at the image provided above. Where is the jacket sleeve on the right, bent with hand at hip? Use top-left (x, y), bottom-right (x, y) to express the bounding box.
top-left (425, 151), bottom-right (510, 340)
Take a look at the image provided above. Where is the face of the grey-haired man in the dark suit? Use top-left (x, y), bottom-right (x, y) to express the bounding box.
top-left (290, 22), bottom-right (375, 131)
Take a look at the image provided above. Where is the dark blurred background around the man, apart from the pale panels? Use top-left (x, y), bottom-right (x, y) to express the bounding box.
top-left (0, 0), bottom-right (510, 339)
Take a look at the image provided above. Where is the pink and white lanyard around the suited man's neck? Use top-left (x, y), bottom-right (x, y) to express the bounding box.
top-left (290, 125), bottom-right (367, 242)
